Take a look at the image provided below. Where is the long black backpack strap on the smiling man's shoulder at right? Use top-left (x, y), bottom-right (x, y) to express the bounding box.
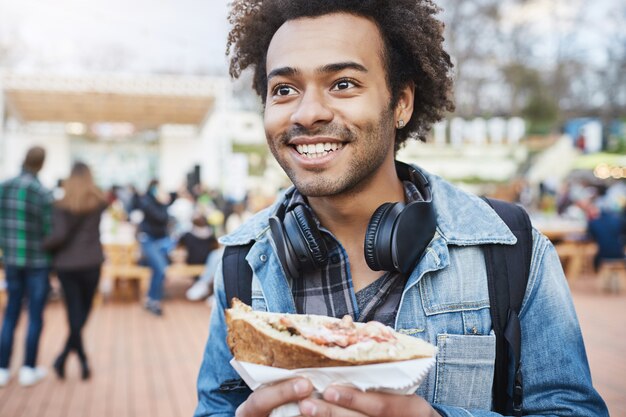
top-left (484, 198), bottom-right (533, 416)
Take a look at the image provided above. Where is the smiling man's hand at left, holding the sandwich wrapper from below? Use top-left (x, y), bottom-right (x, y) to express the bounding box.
top-left (235, 378), bottom-right (313, 417)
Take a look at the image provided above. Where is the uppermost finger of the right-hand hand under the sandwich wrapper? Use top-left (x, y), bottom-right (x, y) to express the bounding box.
top-left (323, 386), bottom-right (432, 417)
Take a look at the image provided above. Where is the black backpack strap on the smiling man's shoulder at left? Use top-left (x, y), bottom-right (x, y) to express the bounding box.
top-left (222, 242), bottom-right (254, 307)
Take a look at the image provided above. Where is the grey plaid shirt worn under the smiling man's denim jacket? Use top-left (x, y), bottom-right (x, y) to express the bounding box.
top-left (287, 181), bottom-right (422, 327)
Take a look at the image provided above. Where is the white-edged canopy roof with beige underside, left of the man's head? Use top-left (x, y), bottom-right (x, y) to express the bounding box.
top-left (0, 73), bottom-right (222, 128)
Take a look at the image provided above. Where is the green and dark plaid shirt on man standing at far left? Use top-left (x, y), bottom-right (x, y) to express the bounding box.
top-left (0, 171), bottom-right (53, 268)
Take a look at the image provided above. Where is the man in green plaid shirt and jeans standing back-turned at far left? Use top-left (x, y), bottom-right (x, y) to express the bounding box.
top-left (0, 146), bottom-right (53, 387)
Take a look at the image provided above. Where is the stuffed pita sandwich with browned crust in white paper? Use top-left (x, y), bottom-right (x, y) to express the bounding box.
top-left (226, 298), bottom-right (437, 369)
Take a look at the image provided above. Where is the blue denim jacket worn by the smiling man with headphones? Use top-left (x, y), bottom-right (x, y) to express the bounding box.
top-left (195, 167), bottom-right (608, 417)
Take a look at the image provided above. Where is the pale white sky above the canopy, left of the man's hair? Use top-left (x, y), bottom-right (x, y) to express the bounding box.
top-left (0, 0), bottom-right (228, 73)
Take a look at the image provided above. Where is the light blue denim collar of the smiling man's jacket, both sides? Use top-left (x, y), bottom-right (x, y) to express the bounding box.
top-left (220, 167), bottom-right (517, 246)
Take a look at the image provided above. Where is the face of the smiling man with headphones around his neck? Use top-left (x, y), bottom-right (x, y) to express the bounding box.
top-left (265, 13), bottom-right (395, 197)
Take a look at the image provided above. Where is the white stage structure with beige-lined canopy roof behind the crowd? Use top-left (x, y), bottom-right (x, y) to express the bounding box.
top-left (0, 72), bottom-right (254, 188)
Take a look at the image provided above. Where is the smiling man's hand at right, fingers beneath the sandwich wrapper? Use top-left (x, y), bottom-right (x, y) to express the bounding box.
top-left (300, 386), bottom-right (441, 417)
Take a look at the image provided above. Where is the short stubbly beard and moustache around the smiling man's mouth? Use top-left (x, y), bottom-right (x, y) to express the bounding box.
top-left (268, 108), bottom-right (395, 197)
